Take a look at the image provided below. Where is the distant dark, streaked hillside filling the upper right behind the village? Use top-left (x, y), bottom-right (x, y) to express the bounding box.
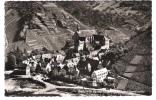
top-left (57, 0), bottom-right (151, 42)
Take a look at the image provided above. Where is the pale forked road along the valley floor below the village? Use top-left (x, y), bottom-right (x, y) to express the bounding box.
top-left (30, 77), bottom-right (140, 96)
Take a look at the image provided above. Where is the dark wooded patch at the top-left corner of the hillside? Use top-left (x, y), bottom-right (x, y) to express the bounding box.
top-left (5, 1), bottom-right (44, 22)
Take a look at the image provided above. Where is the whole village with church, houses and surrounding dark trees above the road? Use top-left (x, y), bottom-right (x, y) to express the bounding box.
top-left (5, 27), bottom-right (128, 88)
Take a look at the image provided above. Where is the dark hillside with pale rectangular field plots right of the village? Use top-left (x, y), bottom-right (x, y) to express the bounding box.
top-left (114, 28), bottom-right (152, 95)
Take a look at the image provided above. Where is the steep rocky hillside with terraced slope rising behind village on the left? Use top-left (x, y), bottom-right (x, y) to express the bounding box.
top-left (5, 2), bottom-right (89, 51)
